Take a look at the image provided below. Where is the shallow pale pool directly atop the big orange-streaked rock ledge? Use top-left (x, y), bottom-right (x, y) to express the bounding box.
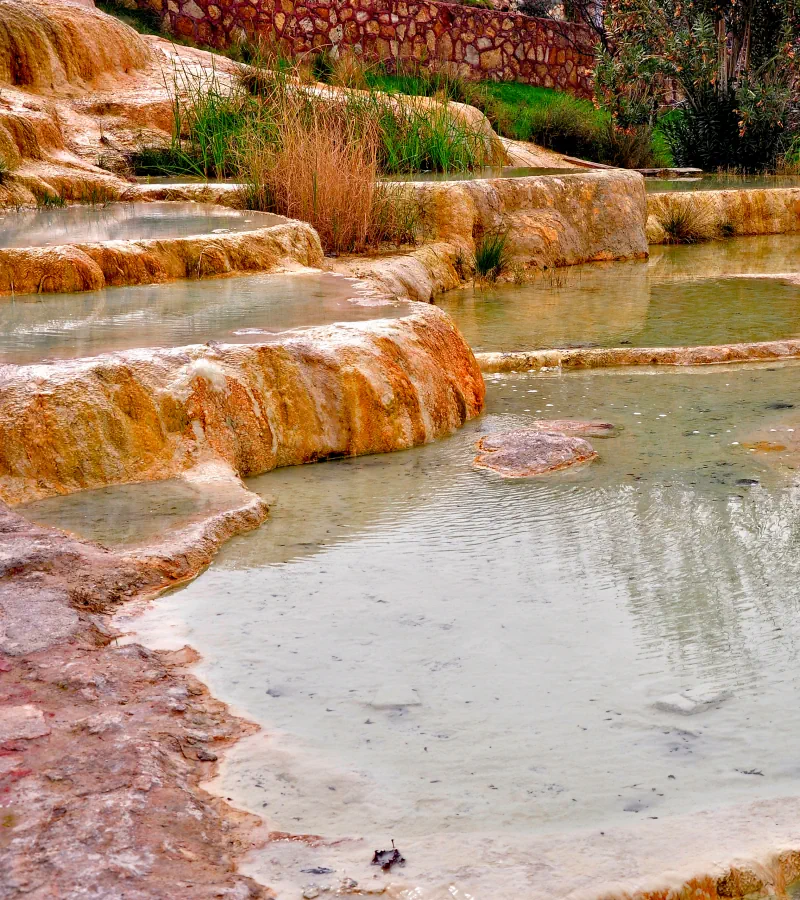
top-left (0, 272), bottom-right (413, 364)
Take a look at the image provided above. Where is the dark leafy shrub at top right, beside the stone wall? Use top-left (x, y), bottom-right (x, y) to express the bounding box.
top-left (596, 0), bottom-right (798, 172)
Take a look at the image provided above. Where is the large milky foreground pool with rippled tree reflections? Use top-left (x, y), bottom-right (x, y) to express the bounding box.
top-left (126, 365), bottom-right (800, 841)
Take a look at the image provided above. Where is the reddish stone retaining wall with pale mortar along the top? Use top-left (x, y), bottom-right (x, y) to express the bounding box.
top-left (136, 0), bottom-right (593, 96)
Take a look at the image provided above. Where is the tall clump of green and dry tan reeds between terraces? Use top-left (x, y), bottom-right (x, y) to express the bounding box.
top-left (132, 52), bottom-right (497, 253)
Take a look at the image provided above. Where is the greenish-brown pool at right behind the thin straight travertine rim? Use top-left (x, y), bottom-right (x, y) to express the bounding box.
top-left (436, 234), bottom-right (800, 351)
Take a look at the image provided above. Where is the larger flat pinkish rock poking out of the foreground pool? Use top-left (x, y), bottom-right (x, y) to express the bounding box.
top-left (473, 427), bottom-right (597, 478)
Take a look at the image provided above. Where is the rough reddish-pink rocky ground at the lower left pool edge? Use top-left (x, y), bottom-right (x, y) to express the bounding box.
top-left (0, 503), bottom-right (271, 900)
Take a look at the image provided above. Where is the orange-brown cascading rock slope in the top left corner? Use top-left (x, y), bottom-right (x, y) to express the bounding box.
top-left (0, 0), bottom-right (241, 206)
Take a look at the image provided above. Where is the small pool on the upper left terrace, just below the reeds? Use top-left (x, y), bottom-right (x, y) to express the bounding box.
top-left (0, 201), bottom-right (287, 249)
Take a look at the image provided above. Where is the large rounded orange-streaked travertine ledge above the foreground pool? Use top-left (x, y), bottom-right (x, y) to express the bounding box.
top-left (0, 304), bottom-right (485, 504)
